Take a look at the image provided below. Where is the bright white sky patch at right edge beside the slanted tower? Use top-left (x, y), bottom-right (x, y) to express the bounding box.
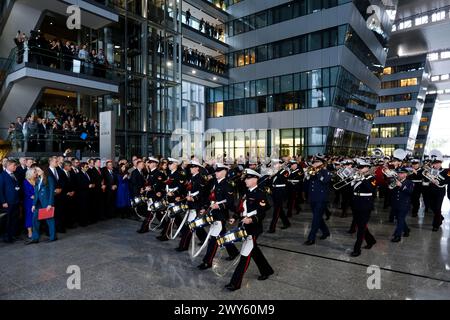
top-left (426, 101), bottom-right (450, 155)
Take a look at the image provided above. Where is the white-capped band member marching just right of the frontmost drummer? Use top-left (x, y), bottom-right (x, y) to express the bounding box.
top-left (268, 159), bottom-right (291, 233)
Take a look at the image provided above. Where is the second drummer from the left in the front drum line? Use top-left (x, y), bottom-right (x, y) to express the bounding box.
top-left (157, 158), bottom-right (187, 241)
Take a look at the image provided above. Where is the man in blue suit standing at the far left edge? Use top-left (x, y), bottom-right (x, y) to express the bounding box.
top-left (0, 160), bottom-right (21, 243)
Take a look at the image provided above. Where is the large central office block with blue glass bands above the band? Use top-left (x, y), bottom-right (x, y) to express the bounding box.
top-left (206, 0), bottom-right (396, 157)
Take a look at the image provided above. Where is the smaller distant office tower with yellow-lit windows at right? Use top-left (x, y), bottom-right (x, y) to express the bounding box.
top-left (369, 54), bottom-right (430, 155)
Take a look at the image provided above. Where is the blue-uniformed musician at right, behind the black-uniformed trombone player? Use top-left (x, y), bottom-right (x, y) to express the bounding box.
top-left (391, 167), bottom-right (414, 242)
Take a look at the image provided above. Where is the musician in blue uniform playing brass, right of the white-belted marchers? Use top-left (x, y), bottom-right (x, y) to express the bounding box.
top-left (305, 154), bottom-right (332, 246)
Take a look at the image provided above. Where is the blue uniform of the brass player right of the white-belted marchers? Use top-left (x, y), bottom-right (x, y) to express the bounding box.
top-left (306, 169), bottom-right (333, 244)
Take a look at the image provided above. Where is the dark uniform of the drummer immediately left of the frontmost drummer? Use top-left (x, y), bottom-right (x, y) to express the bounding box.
top-left (198, 178), bottom-right (239, 270)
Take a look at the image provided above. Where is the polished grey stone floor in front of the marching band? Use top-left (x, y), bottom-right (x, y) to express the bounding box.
top-left (0, 195), bottom-right (450, 300)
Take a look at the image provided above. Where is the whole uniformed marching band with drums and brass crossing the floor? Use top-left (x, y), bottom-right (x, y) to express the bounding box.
top-left (130, 149), bottom-right (450, 291)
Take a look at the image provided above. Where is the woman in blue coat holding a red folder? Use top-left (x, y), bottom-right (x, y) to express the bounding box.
top-left (28, 167), bottom-right (57, 244)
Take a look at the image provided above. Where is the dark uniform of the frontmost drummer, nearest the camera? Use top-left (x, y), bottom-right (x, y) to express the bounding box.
top-left (227, 187), bottom-right (274, 290)
